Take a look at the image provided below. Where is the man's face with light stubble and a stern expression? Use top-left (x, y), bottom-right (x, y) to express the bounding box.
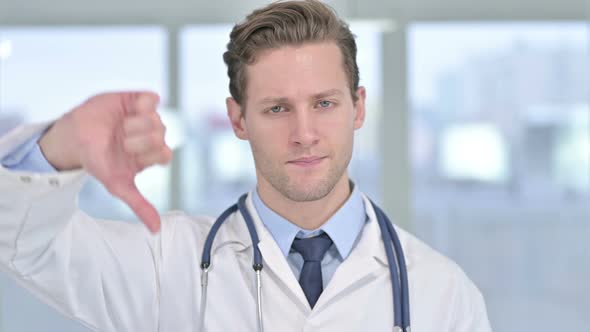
top-left (227, 42), bottom-right (365, 202)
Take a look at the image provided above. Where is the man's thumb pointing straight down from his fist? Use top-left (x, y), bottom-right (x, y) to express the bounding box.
top-left (111, 183), bottom-right (160, 233)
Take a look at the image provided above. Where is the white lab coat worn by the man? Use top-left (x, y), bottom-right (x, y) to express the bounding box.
top-left (0, 125), bottom-right (491, 332)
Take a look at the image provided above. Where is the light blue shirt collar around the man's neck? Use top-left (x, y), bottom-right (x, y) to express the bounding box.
top-left (252, 183), bottom-right (367, 259)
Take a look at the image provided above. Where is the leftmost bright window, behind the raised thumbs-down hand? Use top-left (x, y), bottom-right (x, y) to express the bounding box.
top-left (0, 27), bottom-right (169, 332)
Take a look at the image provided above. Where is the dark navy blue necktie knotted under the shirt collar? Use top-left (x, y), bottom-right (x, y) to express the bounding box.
top-left (292, 233), bottom-right (332, 308)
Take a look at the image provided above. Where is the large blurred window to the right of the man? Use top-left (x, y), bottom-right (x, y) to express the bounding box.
top-left (408, 22), bottom-right (590, 331)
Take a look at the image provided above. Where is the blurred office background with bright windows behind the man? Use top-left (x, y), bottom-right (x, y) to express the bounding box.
top-left (0, 0), bottom-right (590, 332)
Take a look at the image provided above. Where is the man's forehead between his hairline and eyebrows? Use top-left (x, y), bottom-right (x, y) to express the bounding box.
top-left (246, 42), bottom-right (348, 103)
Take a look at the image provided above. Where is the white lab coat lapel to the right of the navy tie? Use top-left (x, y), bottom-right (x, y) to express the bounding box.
top-left (314, 195), bottom-right (388, 312)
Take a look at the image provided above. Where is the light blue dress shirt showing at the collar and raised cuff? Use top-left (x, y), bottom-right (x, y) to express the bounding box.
top-left (0, 135), bottom-right (367, 289)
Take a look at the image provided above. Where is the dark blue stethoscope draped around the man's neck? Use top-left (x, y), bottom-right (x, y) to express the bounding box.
top-left (199, 194), bottom-right (410, 332)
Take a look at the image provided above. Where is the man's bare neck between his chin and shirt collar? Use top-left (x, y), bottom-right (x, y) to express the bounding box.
top-left (258, 173), bottom-right (351, 230)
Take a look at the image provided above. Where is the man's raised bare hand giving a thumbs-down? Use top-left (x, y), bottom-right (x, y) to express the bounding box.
top-left (39, 92), bottom-right (172, 232)
